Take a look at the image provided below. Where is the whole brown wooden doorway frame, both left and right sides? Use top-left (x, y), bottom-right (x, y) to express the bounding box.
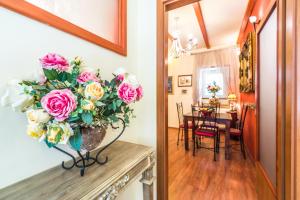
top-left (156, 0), bottom-right (300, 200)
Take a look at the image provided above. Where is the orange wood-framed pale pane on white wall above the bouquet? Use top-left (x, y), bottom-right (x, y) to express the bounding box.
top-left (0, 0), bottom-right (127, 56)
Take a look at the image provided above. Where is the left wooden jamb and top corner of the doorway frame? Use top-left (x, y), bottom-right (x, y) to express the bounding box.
top-left (156, 0), bottom-right (199, 200)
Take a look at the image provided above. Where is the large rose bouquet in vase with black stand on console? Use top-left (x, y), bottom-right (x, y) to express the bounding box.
top-left (1, 53), bottom-right (143, 176)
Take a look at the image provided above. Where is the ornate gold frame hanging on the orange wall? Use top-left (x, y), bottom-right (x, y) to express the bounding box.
top-left (239, 32), bottom-right (255, 92)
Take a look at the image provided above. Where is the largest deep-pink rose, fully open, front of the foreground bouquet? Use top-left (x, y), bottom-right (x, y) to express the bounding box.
top-left (41, 89), bottom-right (77, 121)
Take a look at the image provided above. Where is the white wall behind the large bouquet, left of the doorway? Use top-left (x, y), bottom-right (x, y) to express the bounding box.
top-left (0, 0), bottom-right (156, 200)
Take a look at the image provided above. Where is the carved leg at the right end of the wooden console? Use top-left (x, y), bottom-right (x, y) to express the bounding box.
top-left (141, 166), bottom-right (154, 200)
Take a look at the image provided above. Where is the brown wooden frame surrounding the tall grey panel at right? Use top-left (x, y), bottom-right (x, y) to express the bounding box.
top-left (255, 0), bottom-right (284, 199)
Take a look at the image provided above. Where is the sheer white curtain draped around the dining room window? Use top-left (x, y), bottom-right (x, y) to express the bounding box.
top-left (193, 47), bottom-right (239, 102)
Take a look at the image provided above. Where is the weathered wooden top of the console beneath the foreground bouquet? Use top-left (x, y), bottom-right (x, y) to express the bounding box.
top-left (0, 141), bottom-right (154, 200)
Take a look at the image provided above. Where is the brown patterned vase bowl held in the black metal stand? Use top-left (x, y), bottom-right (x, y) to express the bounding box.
top-left (81, 126), bottom-right (107, 151)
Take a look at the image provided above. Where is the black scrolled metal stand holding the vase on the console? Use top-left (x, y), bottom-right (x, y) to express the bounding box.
top-left (53, 118), bottom-right (126, 176)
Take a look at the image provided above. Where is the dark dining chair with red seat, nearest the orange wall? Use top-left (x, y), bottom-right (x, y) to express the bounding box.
top-left (230, 105), bottom-right (249, 159)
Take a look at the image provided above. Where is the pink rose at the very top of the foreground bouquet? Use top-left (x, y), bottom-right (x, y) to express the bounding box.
top-left (40, 53), bottom-right (69, 72)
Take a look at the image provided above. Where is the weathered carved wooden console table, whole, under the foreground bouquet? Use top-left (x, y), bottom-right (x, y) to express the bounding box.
top-left (0, 141), bottom-right (155, 200)
